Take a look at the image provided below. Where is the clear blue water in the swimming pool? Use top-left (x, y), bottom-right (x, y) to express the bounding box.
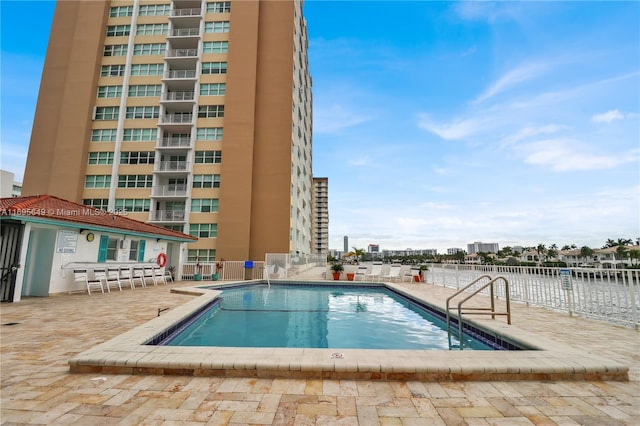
top-left (160, 285), bottom-right (500, 350)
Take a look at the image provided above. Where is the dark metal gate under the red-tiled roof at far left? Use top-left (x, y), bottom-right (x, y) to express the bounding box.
top-left (0, 220), bottom-right (24, 302)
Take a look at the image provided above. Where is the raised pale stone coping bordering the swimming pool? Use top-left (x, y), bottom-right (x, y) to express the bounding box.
top-left (69, 281), bottom-right (628, 381)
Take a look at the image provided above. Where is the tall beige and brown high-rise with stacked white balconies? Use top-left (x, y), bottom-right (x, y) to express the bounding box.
top-left (23, 0), bottom-right (313, 262)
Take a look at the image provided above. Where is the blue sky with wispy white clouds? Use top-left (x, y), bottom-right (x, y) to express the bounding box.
top-left (0, 0), bottom-right (640, 253)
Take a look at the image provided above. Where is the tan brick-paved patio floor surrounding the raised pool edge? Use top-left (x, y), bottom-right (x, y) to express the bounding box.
top-left (0, 283), bottom-right (640, 426)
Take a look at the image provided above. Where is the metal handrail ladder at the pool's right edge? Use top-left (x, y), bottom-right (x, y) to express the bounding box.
top-left (446, 275), bottom-right (511, 349)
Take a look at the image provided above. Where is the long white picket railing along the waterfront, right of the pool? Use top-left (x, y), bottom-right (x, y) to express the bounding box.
top-left (427, 264), bottom-right (640, 328)
